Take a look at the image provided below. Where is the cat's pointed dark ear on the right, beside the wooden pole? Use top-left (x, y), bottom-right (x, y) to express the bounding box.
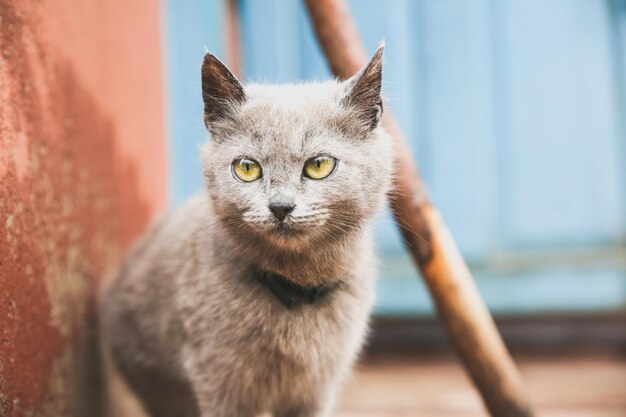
top-left (342, 42), bottom-right (385, 130)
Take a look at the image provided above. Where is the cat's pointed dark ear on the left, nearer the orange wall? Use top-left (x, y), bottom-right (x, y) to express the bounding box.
top-left (202, 53), bottom-right (246, 127)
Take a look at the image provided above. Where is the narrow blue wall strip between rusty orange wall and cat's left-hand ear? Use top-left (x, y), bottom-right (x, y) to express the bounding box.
top-left (162, 0), bottom-right (226, 205)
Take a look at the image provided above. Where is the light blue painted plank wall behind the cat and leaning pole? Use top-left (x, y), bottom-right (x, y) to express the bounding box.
top-left (165, 0), bottom-right (626, 314)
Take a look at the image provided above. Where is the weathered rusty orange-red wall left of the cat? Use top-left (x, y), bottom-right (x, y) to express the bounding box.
top-left (0, 0), bottom-right (165, 417)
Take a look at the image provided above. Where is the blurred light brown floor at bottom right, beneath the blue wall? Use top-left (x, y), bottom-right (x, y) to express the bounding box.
top-left (334, 356), bottom-right (626, 417)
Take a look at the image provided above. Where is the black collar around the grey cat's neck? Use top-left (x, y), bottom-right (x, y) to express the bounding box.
top-left (254, 268), bottom-right (341, 310)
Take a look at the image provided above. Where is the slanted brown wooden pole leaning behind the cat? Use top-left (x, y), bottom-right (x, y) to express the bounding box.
top-left (305, 0), bottom-right (532, 417)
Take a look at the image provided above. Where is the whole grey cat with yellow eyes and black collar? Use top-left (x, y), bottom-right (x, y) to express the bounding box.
top-left (103, 45), bottom-right (392, 417)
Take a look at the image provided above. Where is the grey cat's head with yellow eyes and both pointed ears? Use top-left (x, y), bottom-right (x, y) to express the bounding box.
top-left (202, 46), bottom-right (392, 251)
